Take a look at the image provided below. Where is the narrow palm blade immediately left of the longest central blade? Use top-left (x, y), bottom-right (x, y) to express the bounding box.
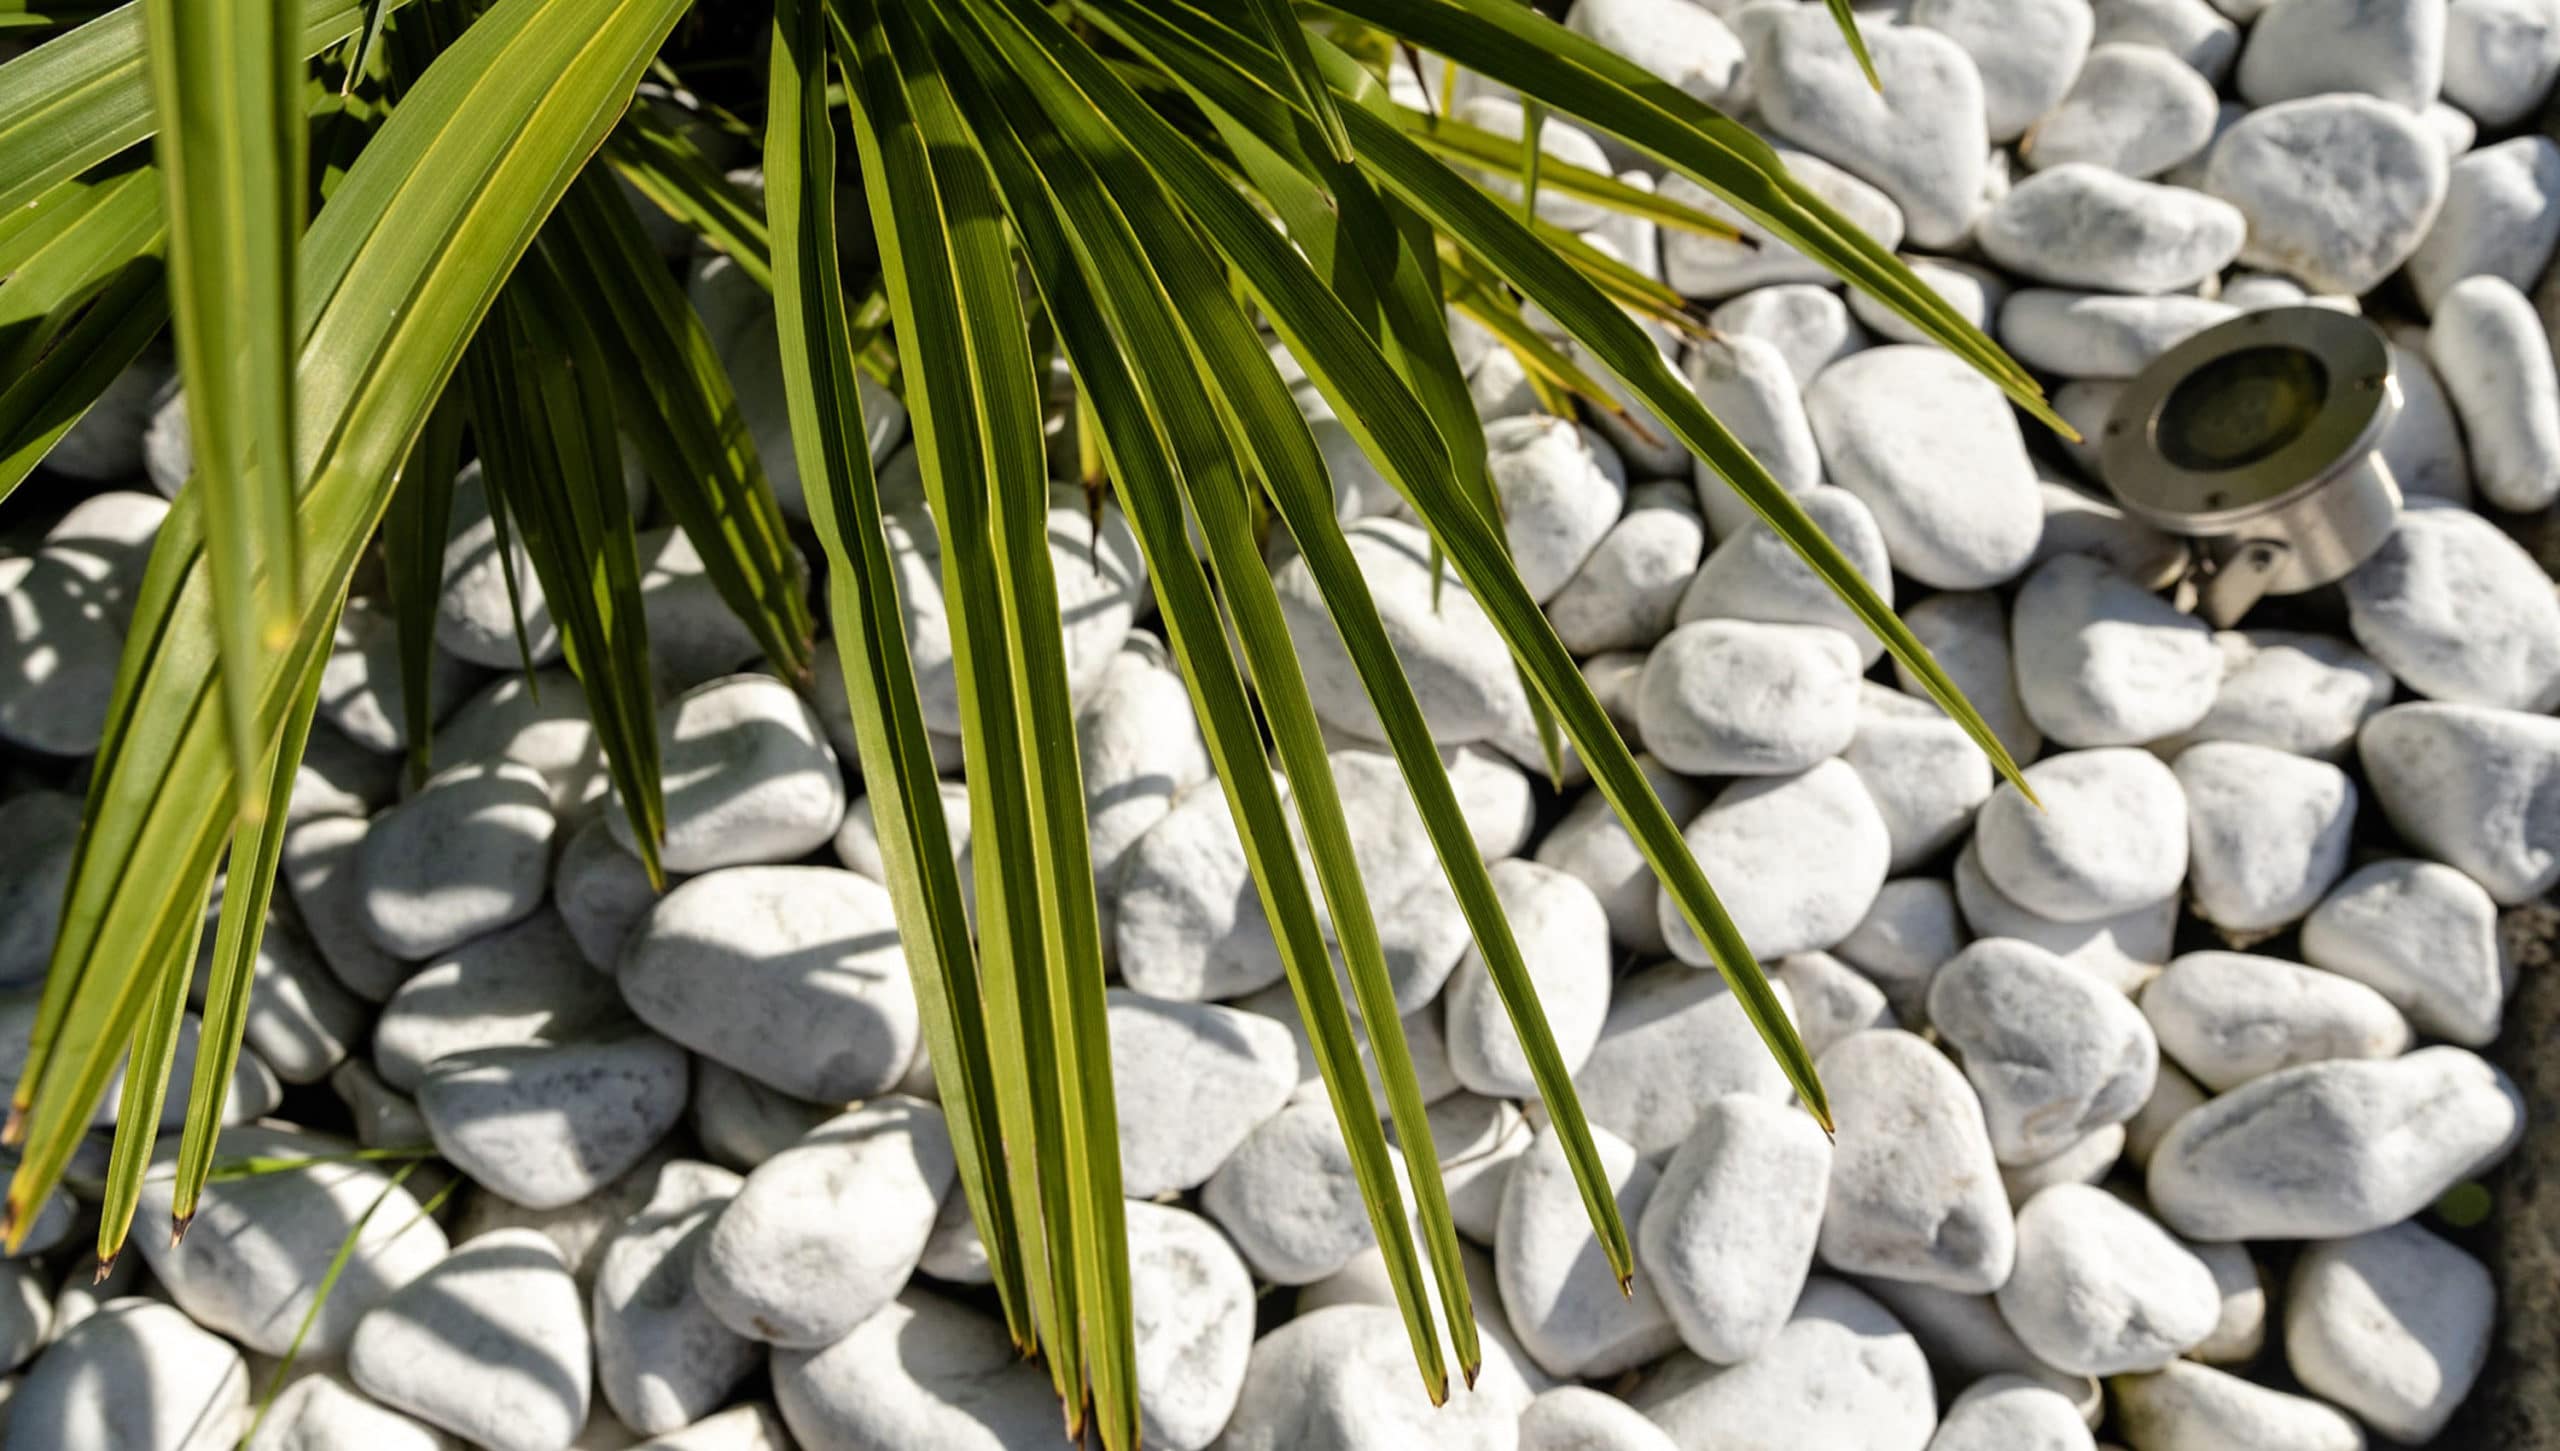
top-left (765, 0), bottom-right (1034, 1349)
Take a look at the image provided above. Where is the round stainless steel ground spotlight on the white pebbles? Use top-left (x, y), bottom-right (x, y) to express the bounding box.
top-left (2099, 307), bottom-right (2401, 627)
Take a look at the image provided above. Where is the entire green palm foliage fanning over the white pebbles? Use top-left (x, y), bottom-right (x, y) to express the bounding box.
top-left (0, 0), bottom-right (2053, 1451)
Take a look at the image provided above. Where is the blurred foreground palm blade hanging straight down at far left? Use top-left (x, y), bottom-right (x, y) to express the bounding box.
top-left (143, 0), bottom-right (305, 824)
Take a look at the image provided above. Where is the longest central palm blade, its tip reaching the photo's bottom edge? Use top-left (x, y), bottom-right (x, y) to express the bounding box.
top-left (835, 0), bottom-right (1137, 1446)
